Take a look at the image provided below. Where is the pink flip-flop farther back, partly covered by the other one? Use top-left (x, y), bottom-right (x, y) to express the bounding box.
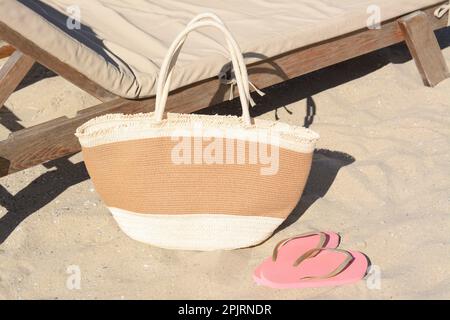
top-left (253, 232), bottom-right (341, 285)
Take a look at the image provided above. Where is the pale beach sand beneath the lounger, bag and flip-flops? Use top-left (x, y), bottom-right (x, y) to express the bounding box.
top-left (0, 30), bottom-right (450, 299)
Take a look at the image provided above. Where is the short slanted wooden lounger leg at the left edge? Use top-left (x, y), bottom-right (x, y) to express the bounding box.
top-left (0, 51), bottom-right (34, 108)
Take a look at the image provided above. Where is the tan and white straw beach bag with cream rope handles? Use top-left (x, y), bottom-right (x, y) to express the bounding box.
top-left (76, 14), bottom-right (319, 250)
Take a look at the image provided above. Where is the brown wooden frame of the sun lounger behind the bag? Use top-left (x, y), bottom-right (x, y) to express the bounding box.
top-left (0, 1), bottom-right (449, 177)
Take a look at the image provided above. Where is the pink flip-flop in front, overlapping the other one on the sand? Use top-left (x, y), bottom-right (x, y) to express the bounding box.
top-left (261, 248), bottom-right (369, 289)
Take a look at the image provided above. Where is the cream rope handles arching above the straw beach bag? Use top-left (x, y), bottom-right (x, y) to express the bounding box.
top-left (155, 13), bottom-right (253, 126)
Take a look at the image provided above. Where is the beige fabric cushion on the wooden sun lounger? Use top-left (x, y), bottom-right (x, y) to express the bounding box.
top-left (0, 0), bottom-right (442, 98)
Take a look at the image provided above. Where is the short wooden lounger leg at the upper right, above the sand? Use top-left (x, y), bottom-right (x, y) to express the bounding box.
top-left (398, 11), bottom-right (450, 87)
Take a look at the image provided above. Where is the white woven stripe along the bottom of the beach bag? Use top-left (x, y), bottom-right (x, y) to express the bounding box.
top-left (109, 208), bottom-right (283, 251)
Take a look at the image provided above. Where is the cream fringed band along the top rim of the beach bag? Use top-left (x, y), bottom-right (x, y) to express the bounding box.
top-left (75, 113), bottom-right (319, 153)
